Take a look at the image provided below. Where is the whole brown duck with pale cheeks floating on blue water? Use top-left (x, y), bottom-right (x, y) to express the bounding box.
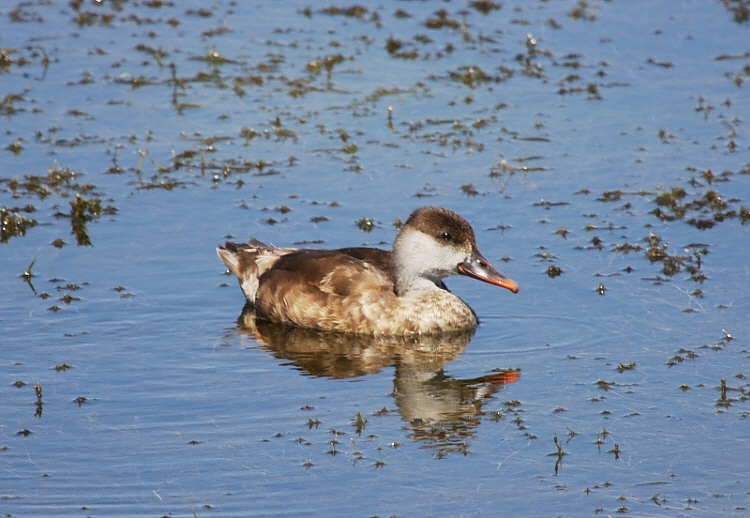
top-left (216, 206), bottom-right (519, 336)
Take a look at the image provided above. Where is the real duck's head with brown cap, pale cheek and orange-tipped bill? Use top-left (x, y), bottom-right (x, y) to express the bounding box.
top-left (392, 207), bottom-right (518, 295)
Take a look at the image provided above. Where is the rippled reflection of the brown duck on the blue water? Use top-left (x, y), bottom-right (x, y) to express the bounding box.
top-left (238, 307), bottom-right (520, 456)
